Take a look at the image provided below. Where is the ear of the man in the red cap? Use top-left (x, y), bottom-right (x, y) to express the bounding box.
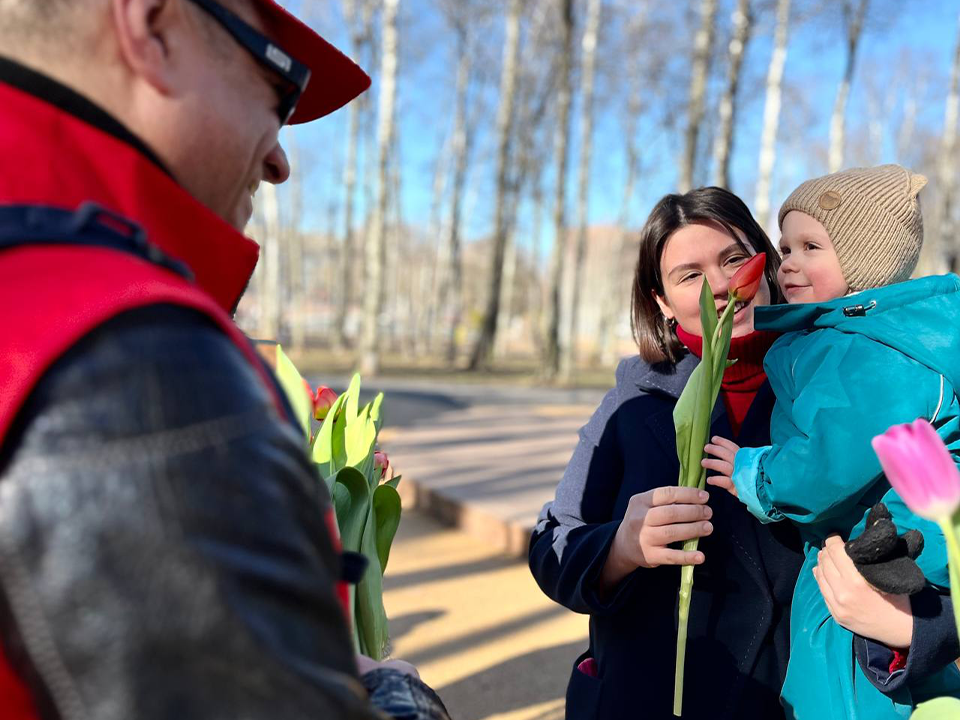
top-left (111, 0), bottom-right (187, 95)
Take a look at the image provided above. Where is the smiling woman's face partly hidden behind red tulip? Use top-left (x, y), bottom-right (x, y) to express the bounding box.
top-left (656, 224), bottom-right (770, 337)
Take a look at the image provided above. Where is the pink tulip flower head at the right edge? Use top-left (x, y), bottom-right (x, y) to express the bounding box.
top-left (872, 419), bottom-right (960, 521)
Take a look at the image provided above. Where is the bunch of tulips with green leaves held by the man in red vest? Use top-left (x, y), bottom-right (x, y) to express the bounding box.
top-left (264, 345), bottom-right (400, 660)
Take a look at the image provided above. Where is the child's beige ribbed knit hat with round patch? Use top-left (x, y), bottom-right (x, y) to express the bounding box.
top-left (777, 165), bottom-right (927, 291)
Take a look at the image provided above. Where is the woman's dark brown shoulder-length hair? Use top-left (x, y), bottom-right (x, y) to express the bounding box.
top-left (630, 187), bottom-right (783, 363)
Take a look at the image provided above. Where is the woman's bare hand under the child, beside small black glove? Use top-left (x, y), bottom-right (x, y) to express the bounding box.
top-left (813, 535), bottom-right (913, 650)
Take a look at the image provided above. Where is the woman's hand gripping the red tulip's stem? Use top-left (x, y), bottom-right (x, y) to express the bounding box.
top-left (600, 485), bottom-right (713, 589)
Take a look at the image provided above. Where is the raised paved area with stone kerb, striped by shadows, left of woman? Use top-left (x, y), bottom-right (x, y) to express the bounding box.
top-left (381, 400), bottom-right (601, 556)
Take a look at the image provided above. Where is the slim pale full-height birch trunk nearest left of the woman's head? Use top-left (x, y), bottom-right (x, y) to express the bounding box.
top-left (560, 0), bottom-right (602, 382)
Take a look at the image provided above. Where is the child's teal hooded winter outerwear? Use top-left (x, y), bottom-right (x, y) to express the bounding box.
top-left (733, 275), bottom-right (960, 720)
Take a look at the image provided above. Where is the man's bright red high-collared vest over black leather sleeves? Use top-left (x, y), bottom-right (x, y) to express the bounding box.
top-left (0, 76), bottom-right (344, 720)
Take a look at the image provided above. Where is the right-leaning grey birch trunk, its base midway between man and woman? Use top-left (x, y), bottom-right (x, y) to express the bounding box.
top-left (469, 0), bottom-right (523, 370)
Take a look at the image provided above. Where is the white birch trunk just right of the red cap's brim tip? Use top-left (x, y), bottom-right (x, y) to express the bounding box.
top-left (360, 0), bottom-right (400, 376)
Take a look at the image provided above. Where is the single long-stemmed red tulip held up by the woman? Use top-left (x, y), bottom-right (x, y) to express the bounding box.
top-left (673, 253), bottom-right (767, 717)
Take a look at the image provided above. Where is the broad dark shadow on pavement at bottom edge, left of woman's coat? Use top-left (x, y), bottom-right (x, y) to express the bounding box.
top-left (437, 639), bottom-right (587, 720)
